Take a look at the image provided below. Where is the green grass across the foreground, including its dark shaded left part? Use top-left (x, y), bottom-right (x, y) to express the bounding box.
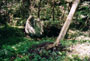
top-left (0, 27), bottom-right (89, 61)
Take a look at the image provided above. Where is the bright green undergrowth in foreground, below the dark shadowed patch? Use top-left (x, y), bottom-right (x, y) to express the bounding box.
top-left (0, 37), bottom-right (86, 61)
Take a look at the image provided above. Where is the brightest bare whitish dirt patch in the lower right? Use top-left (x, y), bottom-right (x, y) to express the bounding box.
top-left (67, 42), bottom-right (90, 59)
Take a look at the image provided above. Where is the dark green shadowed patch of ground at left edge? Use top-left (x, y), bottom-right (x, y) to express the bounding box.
top-left (0, 26), bottom-right (25, 48)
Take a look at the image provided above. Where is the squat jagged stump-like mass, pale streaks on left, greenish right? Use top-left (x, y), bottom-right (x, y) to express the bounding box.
top-left (25, 15), bottom-right (44, 37)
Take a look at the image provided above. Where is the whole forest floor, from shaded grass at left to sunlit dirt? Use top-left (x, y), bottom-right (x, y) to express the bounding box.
top-left (0, 27), bottom-right (90, 61)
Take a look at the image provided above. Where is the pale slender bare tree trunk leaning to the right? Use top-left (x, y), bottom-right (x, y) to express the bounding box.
top-left (47, 0), bottom-right (80, 49)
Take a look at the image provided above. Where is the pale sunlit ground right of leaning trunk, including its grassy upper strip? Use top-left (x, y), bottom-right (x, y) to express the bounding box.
top-left (67, 30), bottom-right (90, 59)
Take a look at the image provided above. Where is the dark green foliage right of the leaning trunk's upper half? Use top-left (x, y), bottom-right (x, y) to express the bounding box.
top-left (72, 1), bottom-right (90, 31)
